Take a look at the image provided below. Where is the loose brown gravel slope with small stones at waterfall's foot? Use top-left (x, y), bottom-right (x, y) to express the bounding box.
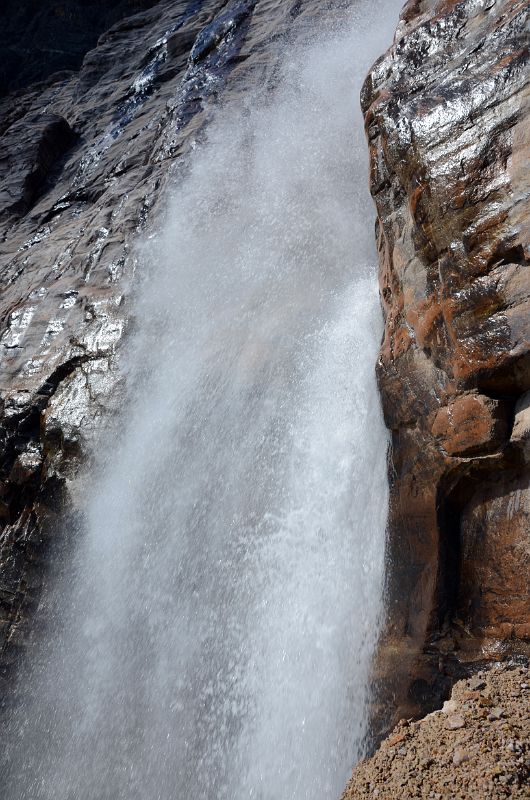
top-left (342, 664), bottom-right (530, 800)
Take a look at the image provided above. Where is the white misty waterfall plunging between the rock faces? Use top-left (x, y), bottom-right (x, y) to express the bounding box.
top-left (1, 3), bottom-right (397, 800)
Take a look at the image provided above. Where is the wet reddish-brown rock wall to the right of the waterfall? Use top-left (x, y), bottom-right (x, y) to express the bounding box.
top-left (362, 0), bottom-right (530, 716)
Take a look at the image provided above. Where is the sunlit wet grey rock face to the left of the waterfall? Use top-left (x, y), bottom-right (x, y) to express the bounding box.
top-left (0, 0), bottom-right (348, 678)
